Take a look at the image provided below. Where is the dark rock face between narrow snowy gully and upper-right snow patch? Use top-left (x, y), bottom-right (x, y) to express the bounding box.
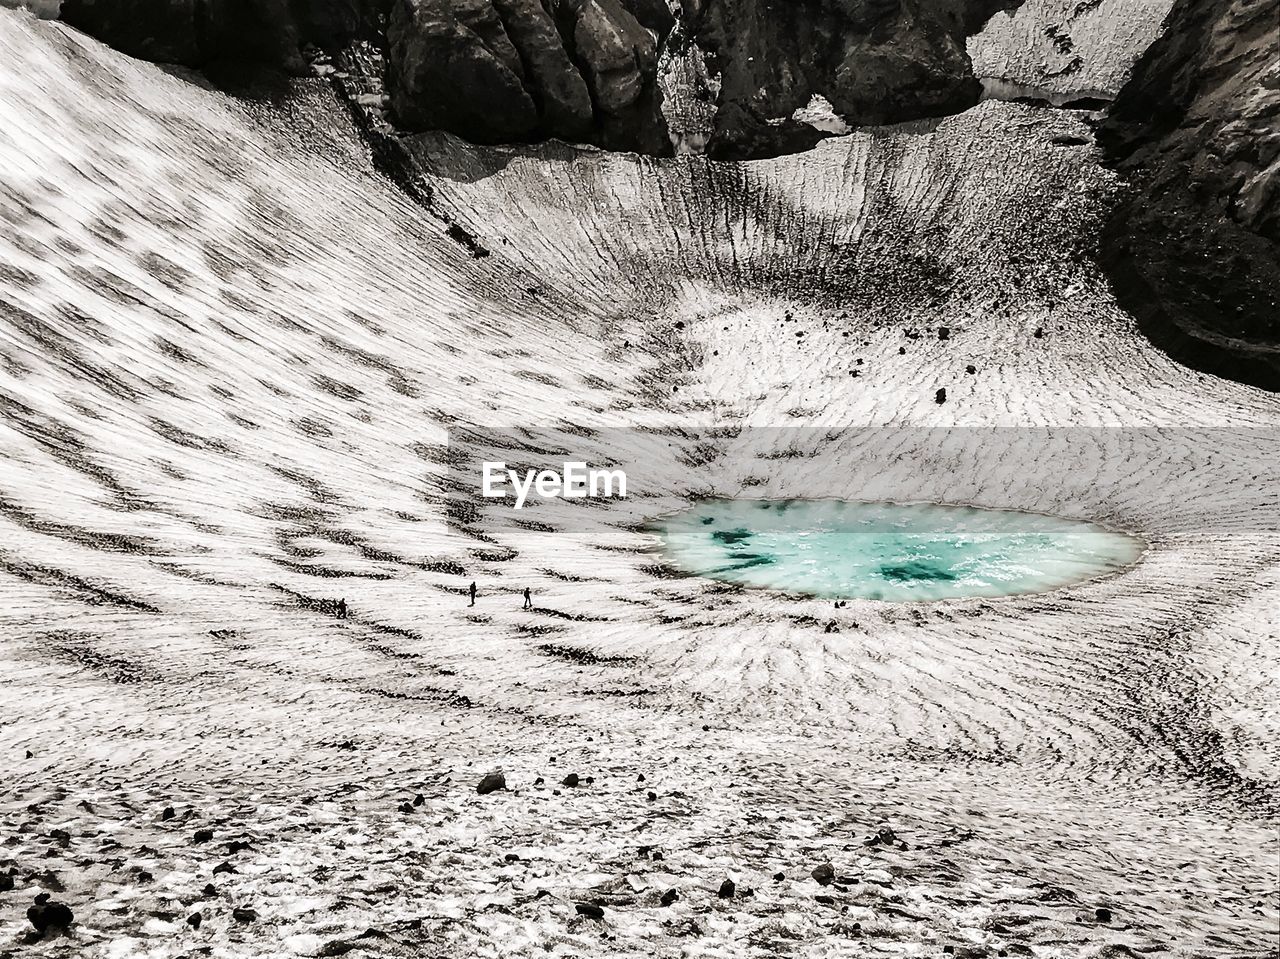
top-left (684, 0), bottom-right (1018, 159)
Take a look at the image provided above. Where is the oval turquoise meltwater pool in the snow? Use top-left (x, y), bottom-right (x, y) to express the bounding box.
top-left (654, 499), bottom-right (1146, 602)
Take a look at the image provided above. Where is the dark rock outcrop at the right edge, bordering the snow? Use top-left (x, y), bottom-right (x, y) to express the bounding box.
top-left (1101, 0), bottom-right (1280, 389)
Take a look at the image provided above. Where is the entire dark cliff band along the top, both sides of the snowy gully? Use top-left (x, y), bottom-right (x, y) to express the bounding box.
top-left (55, 0), bottom-right (1018, 159)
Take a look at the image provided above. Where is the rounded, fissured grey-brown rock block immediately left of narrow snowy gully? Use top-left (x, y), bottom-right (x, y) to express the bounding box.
top-left (387, 0), bottom-right (675, 154)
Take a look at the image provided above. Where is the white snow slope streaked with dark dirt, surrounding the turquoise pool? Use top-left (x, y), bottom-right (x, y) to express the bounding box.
top-left (0, 10), bottom-right (1280, 956)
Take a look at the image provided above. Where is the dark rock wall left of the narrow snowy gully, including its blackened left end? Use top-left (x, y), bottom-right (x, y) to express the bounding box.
top-left (61, 0), bottom-right (675, 154)
